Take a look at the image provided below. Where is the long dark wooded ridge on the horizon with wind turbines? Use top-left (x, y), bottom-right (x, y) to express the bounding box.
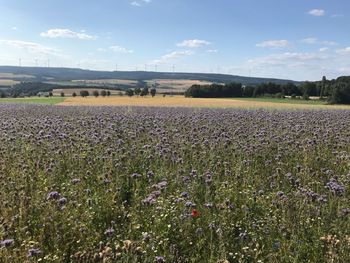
top-left (0, 66), bottom-right (298, 85)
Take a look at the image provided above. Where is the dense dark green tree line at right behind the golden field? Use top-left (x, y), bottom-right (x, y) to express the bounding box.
top-left (185, 77), bottom-right (350, 104)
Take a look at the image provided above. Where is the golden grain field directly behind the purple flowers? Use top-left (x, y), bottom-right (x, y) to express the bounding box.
top-left (59, 96), bottom-right (350, 109)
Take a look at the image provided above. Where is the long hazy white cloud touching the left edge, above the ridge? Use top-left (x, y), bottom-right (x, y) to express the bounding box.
top-left (0, 40), bottom-right (62, 56)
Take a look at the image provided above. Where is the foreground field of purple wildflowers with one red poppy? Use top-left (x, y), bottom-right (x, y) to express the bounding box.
top-left (0, 105), bottom-right (350, 263)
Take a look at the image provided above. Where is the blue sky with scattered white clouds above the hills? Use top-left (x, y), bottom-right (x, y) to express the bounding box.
top-left (0, 0), bottom-right (350, 80)
